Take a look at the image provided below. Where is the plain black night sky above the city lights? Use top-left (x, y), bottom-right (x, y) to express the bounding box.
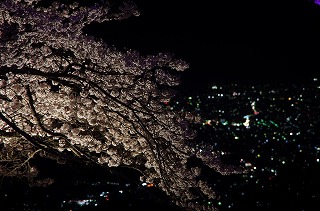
top-left (84, 0), bottom-right (320, 90)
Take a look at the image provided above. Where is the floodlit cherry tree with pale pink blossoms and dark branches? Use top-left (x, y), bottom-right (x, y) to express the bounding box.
top-left (0, 0), bottom-right (244, 210)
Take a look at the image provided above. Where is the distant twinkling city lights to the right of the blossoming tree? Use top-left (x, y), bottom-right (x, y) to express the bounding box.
top-left (169, 78), bottom-right (320, 208)
